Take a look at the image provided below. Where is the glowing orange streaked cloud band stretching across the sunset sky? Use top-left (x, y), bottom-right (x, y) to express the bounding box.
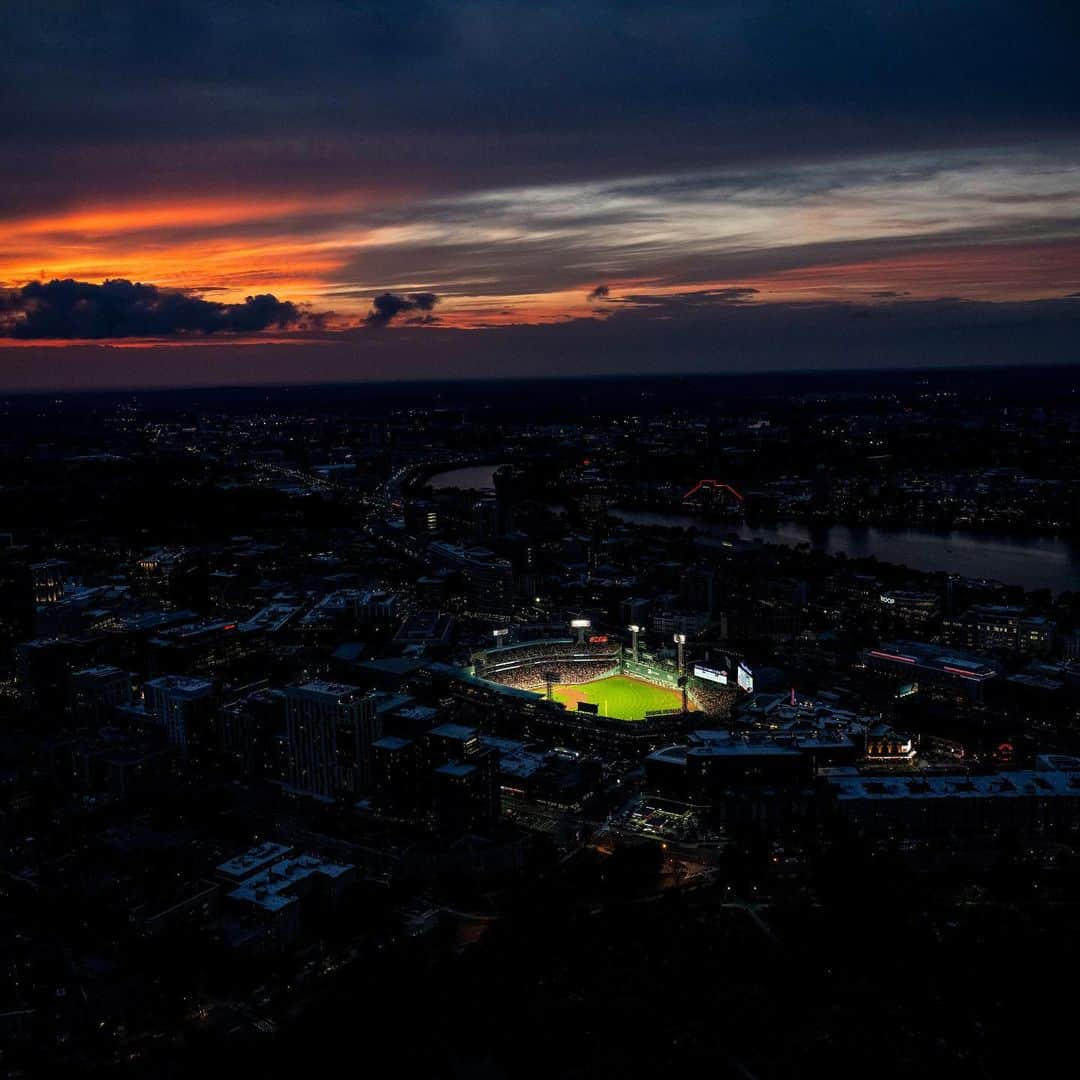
top-left (0, 177), bottom-right (1080, 343)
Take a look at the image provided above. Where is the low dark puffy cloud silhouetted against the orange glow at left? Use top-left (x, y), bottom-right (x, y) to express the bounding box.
top-left (0, 279), bottom-right (306, 339)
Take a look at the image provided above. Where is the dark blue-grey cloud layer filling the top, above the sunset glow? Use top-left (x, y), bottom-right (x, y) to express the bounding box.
top-left (0, 0), bottom-right (1080, 221)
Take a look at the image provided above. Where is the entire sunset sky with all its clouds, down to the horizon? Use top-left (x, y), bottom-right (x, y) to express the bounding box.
top-left (0, 0), bottom-right (1080, 390)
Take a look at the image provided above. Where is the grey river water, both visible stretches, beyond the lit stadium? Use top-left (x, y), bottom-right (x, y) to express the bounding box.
top-left (429, 464), bottom-right (1080, 594)
